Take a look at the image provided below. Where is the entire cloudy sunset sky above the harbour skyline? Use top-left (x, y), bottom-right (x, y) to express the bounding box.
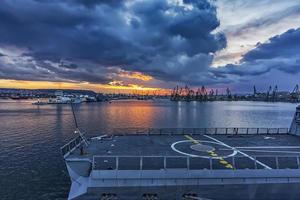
top-left (0, 0), bottom-right (300, 92)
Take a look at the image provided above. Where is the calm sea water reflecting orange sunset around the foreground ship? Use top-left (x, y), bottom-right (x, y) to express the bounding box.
top-left (0, 100), bottom-right (297, 200)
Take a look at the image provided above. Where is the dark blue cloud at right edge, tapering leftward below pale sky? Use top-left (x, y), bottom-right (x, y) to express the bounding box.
top-left (210, 28), bottom-right (300, 78)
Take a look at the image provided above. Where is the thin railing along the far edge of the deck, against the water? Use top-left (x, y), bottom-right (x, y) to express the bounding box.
top-left (101, 127), bottom-right (289, 135)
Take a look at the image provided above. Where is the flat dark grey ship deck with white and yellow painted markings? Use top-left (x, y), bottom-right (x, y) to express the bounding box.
top-left (66, 134), bottom-right (300, 170)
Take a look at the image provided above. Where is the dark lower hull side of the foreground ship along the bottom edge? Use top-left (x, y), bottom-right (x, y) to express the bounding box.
top-left (71, 183), bottom-right (300, 200)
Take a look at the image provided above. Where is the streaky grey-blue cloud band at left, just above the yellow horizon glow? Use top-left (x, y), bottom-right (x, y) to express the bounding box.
top-left (0, 59), bottom-right (114, 83)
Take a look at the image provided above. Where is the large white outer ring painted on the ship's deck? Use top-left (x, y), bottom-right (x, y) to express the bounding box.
top-left (171, 140), bottom-right (237, 159)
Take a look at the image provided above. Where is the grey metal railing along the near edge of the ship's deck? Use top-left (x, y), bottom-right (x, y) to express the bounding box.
top-left (92, 155), bottom-right (300, 171)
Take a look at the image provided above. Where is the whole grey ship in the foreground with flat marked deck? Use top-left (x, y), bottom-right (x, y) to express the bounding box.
top-left (61, 106), bottom-right (300, 200)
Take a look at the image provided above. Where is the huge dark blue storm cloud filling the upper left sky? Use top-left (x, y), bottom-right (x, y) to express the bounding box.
top-left (0, 0), bottom-right (226, 83)
